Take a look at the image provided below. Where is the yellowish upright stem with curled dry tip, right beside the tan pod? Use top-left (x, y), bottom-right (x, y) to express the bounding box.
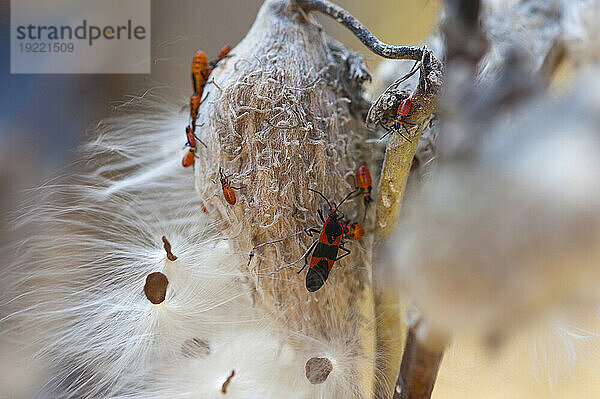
top-left (367, 50), bottom-right (442, 398)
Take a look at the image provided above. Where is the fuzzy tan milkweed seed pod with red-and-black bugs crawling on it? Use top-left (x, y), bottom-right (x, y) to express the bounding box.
top-left (195, 0), bottom-right (375, 390)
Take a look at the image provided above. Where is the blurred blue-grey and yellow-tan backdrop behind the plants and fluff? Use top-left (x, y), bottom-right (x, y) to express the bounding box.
top-left (5, 0), bottom-right (600, 398)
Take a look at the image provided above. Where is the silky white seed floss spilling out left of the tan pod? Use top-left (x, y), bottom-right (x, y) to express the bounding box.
top-left (0, 98), bottom-right (332, 398)
